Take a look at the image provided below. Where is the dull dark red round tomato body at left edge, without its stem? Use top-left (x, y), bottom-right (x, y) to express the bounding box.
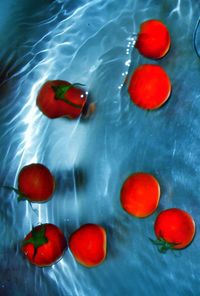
top-left (18, 163), bottom-right (55, 202)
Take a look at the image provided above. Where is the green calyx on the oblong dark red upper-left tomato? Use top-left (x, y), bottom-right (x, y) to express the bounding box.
top-left (52, 83), bottom-right (83, 109)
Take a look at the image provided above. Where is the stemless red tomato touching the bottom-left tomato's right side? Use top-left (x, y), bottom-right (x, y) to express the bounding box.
top-left (69, 224), bottom-right (106, 267)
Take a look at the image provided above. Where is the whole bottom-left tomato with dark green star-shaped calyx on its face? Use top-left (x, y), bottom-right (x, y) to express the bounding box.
top-left (22, 224), bottom-right (67, 267)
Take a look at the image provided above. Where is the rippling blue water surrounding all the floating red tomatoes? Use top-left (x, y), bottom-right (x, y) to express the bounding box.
top-left (0, 0), bottom-right (200, 296)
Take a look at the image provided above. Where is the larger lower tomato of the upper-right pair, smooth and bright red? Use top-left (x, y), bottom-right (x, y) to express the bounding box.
top-left (128, 64), bottom-right (171, 110)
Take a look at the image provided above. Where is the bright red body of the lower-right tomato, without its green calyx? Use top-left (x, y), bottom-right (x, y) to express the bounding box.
top-left (154, 208), bottom-right (195, 249)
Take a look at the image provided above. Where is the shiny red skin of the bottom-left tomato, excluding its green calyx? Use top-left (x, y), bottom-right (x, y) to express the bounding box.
top-left (22, 223), bottom-right (67, 267)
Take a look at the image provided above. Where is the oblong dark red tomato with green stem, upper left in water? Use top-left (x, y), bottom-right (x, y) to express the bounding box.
top-left (37, 80), bottom-right (87, 119)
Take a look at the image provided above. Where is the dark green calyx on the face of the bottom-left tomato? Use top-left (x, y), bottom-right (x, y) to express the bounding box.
top-left (22, 224), bottom-right (48, 257)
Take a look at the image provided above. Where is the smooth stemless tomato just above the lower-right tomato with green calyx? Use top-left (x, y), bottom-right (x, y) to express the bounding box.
top-left (121, 173), bottom-right (160, 218)
